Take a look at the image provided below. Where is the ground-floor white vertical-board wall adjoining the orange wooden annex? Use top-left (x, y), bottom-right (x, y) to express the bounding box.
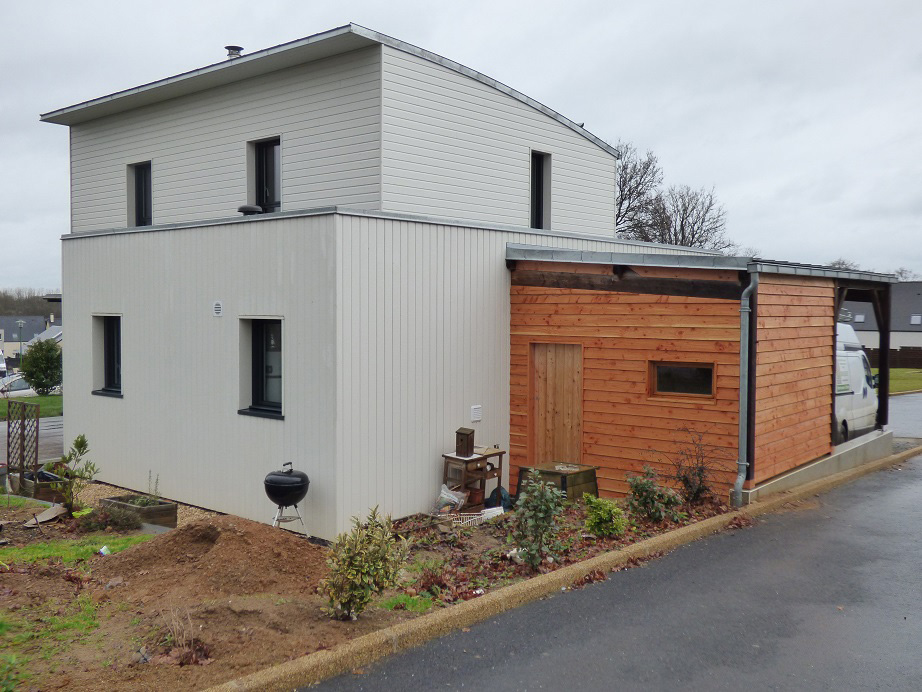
top-left (336, 215), bottom-right (694, 529)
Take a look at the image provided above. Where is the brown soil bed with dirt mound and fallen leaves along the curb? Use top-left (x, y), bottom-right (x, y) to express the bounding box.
top-left (0, 494), bottom-right (727, 690)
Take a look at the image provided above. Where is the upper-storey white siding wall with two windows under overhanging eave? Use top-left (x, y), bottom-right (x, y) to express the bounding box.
top-left (71, 46), bottom-right (381, 231)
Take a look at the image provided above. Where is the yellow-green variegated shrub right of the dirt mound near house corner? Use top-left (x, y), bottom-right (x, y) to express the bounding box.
top-left (320, 507), bottom-right (410, 620)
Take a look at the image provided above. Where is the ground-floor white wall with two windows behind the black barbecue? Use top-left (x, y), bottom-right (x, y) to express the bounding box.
top-left (64, 216), bottom-right (336, 536)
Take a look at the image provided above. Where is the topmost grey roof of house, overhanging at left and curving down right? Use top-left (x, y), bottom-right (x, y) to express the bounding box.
top-left (40, 23), bottom-right (618, 158)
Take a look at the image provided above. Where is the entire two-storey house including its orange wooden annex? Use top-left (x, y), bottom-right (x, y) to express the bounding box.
top-left (42, 25), bottom-right (891, 538)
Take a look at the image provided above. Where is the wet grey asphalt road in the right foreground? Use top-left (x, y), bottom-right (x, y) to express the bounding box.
top-left (319, 454), bottom-right (922, 692)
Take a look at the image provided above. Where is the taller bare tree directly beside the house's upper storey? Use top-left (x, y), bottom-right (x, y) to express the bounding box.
top-left (614, 140), bottom-right (663, 237)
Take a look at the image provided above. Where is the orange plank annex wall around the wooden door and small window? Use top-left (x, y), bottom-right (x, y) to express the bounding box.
top-left (509, 285), bottom-right (740, 496)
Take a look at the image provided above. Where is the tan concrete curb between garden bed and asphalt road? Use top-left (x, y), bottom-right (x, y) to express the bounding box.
top-left (211, 446), bottom-right (922, 692)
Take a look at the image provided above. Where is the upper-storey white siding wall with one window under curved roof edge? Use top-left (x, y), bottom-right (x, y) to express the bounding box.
top-left (382, 46), bottom-right (615, 235)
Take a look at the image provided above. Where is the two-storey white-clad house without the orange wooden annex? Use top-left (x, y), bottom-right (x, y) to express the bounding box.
top-left (42, 25), bottom-right (760, 538)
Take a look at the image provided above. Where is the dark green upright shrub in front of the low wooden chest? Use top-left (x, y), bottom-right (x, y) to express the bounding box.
top-left (509, 469), bottom-right (563, 570)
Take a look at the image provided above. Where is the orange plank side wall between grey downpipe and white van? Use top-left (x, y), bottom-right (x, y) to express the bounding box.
top-left (754, 274), bottom-right (835, 483)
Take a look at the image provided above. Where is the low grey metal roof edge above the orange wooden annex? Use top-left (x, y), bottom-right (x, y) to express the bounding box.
top-left (506, 243), bottom-right (897, 284)
